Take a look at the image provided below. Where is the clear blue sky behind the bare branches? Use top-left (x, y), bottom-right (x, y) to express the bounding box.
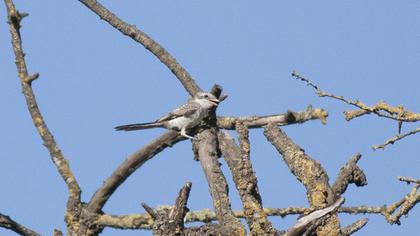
top-left (0, 0), bottom-right (420, 235)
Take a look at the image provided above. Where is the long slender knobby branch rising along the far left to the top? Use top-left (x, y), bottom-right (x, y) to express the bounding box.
top-left (5, 0), bottom-right (81, 208)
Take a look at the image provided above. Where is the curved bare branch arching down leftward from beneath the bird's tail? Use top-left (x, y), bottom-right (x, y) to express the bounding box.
top-left (88, 131), bottom-right (185, 213)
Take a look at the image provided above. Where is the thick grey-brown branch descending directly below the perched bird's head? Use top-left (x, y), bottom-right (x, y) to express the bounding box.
top-left (193, 128), bottom-right (245, 235)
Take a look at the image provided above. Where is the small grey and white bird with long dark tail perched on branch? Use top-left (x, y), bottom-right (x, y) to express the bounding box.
top-left (115, 92), bottom-right (220, 139)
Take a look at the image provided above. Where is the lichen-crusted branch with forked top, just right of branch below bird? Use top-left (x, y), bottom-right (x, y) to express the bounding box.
top-left (218, 128), bottom-right (276, 235)
